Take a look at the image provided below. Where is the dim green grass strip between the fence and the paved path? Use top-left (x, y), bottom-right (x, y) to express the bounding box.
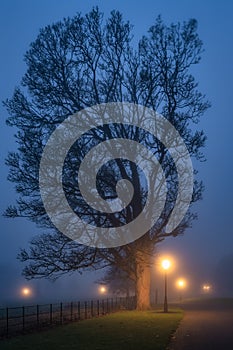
top-left (0, 309), bottom-right (183, 350)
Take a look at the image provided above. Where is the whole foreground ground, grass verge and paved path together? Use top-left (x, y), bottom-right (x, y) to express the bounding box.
top-left (0, 299), bottom-right (233, 350)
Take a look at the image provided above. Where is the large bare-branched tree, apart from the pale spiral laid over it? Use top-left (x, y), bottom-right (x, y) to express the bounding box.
top-left (5, 8), bottom-right (209, 309)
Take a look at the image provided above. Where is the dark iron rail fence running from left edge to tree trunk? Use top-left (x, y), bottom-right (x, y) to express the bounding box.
top-left (0, 297), bottom-right (136, 337)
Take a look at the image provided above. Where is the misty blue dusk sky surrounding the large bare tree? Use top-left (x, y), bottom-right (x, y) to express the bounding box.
top-left (0, 0), bottom-right (233, 304)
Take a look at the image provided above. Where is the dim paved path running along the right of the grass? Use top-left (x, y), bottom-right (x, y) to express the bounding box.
top-left (168, 299), bottom-right (233, 350)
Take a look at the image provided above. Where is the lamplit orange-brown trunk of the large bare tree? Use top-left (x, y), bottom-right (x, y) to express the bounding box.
top-left (136, 251), bottom-right (151, 310)
